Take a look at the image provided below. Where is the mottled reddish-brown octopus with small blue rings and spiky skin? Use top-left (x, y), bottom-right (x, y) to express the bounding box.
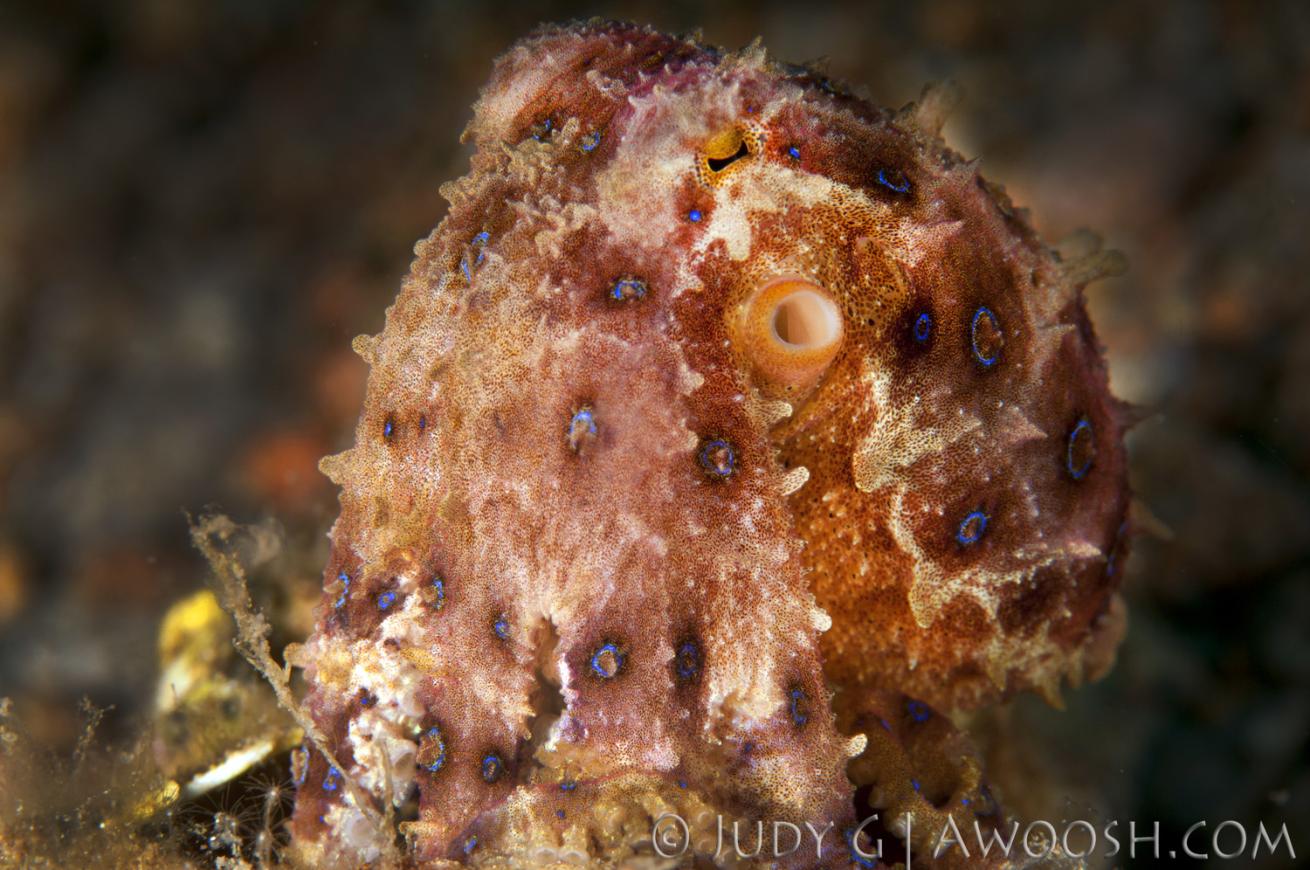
top-left (292, 22), bottom-right (1128, 866)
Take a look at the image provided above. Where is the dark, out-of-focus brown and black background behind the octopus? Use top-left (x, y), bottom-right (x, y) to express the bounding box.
top-left (0, 0), bottom-right (1310, 866)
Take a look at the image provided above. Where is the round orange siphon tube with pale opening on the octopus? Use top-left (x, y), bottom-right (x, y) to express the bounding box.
top-left (738, 278), bottom-right (844, 389)
